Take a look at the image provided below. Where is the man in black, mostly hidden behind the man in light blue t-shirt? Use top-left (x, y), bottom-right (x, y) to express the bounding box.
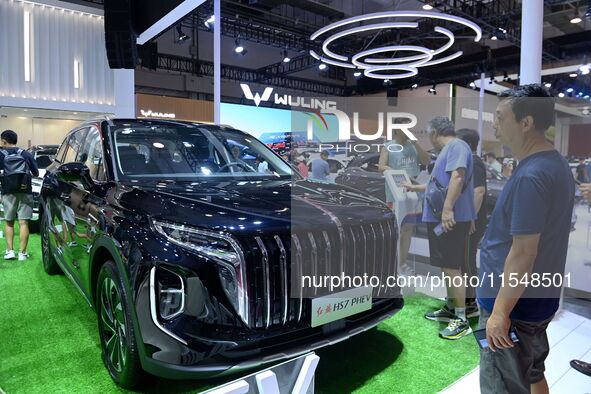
top-left (456, 129), bottom-right (487, 316)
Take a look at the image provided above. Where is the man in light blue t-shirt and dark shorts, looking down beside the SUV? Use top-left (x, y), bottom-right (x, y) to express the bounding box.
top-left (407, 117), bottom-right (476, 339)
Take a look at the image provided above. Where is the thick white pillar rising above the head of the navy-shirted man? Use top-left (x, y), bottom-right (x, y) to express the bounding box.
top-left (519, 0), bottom-right (544, 85)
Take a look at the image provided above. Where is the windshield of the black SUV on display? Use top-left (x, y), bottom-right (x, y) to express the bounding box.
top-left (114, 124), bottom-right (293, 180)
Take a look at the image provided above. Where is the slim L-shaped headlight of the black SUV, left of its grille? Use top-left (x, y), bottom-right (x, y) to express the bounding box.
top-left (152, 220), bottom-right (249, 325)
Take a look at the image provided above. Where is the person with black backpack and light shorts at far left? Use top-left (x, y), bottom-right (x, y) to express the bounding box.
top-left (0, 130), bottom-right (39, 261)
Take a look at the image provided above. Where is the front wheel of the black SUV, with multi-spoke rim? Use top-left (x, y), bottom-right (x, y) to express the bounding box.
top-left (96, 261), bottom-right (143, 388)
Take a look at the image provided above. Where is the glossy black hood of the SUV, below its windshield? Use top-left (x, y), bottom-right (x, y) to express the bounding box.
top-left (115, 179), bottom-right (394, 233)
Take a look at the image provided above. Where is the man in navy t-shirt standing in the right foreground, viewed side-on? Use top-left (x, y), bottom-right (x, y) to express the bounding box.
top-left (477, 84), bottom-right (575, 394)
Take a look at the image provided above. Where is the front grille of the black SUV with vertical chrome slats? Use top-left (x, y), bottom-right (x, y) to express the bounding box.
top-left (241, 221), bottom-right (398, 329)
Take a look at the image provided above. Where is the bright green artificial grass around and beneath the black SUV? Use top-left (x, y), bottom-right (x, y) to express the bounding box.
top-left (0, 231), bottom-right (478, 394)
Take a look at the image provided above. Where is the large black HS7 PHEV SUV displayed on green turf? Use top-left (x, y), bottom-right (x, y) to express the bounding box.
top-left (41, 119), bottom-right (403, 387)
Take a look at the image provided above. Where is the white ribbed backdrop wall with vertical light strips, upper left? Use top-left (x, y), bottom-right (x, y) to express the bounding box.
top-left (0, 0), bottom-right (115, 112)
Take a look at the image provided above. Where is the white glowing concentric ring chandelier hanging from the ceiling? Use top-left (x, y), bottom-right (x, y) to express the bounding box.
top-left (310, 11), bottom-right (482, 79)
